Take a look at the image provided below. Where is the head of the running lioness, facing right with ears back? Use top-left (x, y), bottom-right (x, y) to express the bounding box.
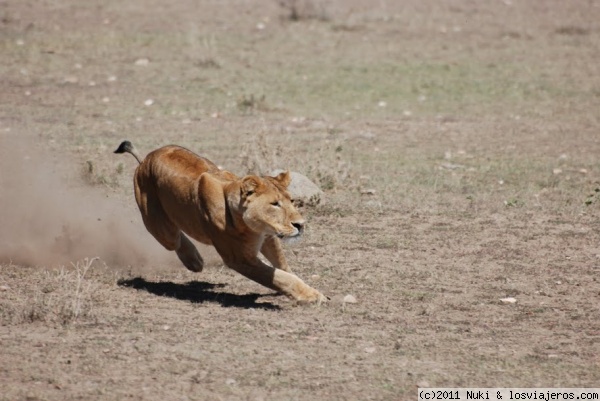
top-left (241, 171), bottom-right (304, 239)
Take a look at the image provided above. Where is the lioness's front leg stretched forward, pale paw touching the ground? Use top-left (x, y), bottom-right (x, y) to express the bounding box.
top-left (229, 258), bottom-right (327, 303)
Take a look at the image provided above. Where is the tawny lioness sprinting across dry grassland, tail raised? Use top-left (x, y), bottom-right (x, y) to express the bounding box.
top-left (115, 141), bottom-right (326, 303)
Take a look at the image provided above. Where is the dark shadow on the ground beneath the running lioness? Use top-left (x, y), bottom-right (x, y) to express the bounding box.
top-left (117, 277), bottom-right (281, 310)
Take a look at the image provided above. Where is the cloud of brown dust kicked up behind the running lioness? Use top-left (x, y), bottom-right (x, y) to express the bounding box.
top-left (0, 132), bottom-right (174, 270)
